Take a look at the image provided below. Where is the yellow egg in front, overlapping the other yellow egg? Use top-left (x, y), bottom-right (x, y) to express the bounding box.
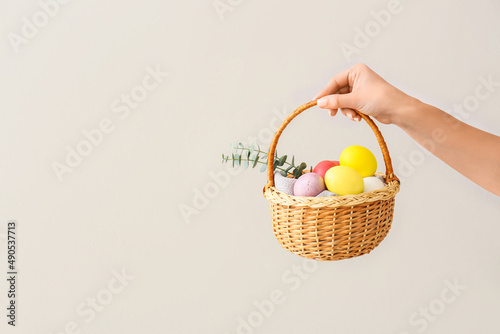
top-left (325, 165), bottom-right (365, 195)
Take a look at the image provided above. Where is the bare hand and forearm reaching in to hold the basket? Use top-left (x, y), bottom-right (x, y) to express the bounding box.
top-left (314, 64), bottom-right (500, 196)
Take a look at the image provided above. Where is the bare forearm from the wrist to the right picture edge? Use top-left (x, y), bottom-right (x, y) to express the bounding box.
top-left (395, 100), bottom-right (500, 196)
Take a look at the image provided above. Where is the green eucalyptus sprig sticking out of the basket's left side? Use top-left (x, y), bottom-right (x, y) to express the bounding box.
top-left (222, 143), bottom-right (307, 179)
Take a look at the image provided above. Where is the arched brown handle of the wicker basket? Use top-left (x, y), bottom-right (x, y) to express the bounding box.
top-left (264, 100), bottom-right (399, 189)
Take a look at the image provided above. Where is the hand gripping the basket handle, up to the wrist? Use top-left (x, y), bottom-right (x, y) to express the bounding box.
top-left (314, 64), bottom-right (419, 124)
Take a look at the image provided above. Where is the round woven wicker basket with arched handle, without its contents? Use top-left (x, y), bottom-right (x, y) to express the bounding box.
top-left (264, 101), bottom-right (399, 261)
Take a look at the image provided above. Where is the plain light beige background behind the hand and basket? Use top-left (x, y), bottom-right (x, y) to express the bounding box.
top-left (0, 0), bottom-right (500, 334)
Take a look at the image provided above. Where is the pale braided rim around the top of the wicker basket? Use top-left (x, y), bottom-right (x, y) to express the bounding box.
top-left (264, 175), bottom-right (400, 208)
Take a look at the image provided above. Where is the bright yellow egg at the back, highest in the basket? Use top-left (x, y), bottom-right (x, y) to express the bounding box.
top-left (339, 145), bottom-right (377, 177)
